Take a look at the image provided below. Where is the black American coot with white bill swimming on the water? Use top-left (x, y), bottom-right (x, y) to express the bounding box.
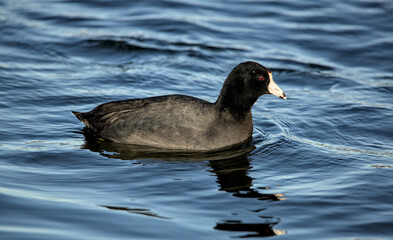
top-left (72, 61), bottom-right (286, 151)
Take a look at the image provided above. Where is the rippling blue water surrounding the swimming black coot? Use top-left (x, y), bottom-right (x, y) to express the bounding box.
top-left (0, 0), bottom-right (393, 239)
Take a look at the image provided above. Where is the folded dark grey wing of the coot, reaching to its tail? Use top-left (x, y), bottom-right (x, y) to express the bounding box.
top-left (73, 95), bottom-right (216, 144)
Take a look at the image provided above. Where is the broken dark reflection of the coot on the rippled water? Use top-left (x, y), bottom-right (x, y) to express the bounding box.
top-left (82, 128), bottom-right (286, 238)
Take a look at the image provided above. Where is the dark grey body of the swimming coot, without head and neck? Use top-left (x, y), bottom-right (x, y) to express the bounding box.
top-left (74, 95), bottom-right (252, 151)
